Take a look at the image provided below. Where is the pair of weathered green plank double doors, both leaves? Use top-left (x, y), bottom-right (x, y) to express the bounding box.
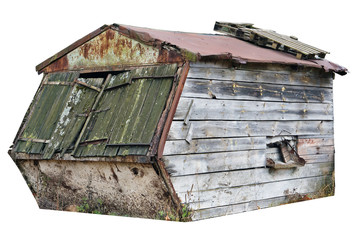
top-left (15, 64), bottom-right (177, 159)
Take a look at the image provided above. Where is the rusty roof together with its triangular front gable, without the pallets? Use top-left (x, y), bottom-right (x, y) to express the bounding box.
top-left (36, 24), bottom-right (347, 75)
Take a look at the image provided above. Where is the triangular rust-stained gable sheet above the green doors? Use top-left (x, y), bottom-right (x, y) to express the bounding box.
top-left (40, 28), bottom-right (183, 73)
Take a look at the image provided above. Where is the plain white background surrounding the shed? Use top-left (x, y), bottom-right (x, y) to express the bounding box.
top-left (0, 0), bottom-right (361, 240)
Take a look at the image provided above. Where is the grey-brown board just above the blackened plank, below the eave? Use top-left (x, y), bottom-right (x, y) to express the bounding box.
top-left (188, 66), bottom-right (333, 88)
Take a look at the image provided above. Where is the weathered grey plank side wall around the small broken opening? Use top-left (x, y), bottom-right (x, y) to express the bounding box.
top-left (163, 63), bottom-right (334, 220)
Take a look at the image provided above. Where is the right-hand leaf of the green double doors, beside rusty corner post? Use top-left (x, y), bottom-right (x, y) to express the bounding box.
top-left (75, 64), bottom-right (177, 156)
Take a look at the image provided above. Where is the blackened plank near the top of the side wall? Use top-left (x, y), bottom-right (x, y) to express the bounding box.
top-left (182, 78), bottom-right (332, 103)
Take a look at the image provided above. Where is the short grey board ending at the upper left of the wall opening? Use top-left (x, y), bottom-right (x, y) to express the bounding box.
top-left (163, 137), bottom-right (266, 156)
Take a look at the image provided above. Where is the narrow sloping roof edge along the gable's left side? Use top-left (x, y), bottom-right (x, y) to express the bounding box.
top-left (35, 24), bottom-right (110, 74)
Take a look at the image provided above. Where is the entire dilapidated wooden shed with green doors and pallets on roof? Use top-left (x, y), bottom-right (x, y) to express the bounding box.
top-left (9, 22), bottom-right (347, 221)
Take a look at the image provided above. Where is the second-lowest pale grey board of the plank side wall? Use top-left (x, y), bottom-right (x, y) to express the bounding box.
top-left (183, 175), bottom-right (331, 210)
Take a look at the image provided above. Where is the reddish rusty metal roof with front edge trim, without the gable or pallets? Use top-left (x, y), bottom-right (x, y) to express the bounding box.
top-left (36, 24), bottom-right (347, 75)
